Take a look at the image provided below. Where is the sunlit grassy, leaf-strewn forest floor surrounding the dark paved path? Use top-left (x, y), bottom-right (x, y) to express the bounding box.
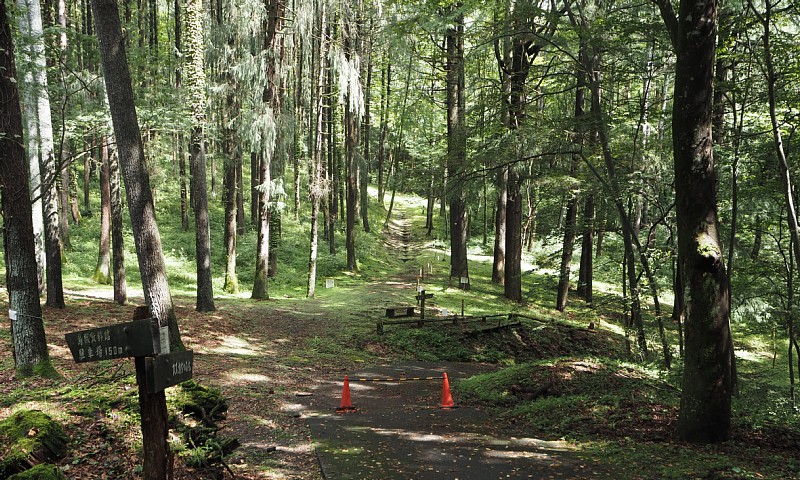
top-left (0, 189), bottom-right (800, 479)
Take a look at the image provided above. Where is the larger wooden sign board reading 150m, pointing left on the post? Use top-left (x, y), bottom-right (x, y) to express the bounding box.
top-left (66, 318), bottom-right (161, 363)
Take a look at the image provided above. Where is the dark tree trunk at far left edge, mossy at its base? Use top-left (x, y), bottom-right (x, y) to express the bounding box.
top-left (0, 2), bottom-right (52, 376)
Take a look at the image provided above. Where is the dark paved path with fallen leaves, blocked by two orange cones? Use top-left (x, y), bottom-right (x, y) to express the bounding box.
top-left (301, 363), bottom-right (615, 480)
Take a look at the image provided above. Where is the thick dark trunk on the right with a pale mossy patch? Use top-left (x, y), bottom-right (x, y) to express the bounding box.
top-left (658, 0), bottom-right (732, 442)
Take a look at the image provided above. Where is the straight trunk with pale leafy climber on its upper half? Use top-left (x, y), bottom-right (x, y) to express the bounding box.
top-left (185, 0), bottom-right (216, 312)
